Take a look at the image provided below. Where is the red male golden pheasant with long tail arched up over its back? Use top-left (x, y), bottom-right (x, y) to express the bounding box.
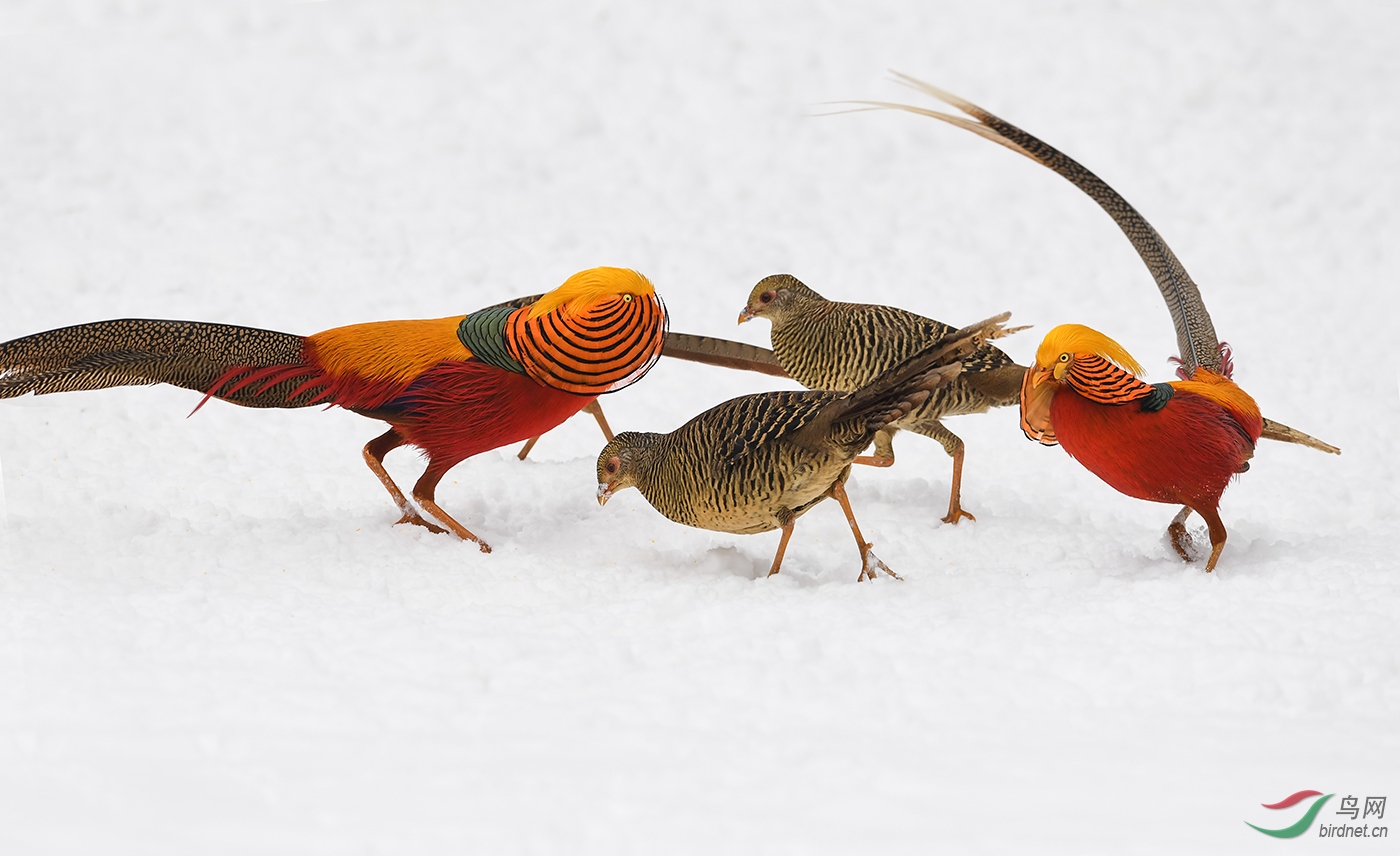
top-left (869, 74), bottom-right (1340, 572)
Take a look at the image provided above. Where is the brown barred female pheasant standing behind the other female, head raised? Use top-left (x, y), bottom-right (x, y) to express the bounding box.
top-left (739, 273), bottom-right (1026, 524)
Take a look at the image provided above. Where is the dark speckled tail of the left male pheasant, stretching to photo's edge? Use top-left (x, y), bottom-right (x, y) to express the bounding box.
top-left (0, 318), bottom-right (319, 409)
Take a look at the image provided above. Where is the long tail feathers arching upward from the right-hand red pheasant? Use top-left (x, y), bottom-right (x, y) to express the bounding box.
top-left (857, 71), bottom-right (1221, 371)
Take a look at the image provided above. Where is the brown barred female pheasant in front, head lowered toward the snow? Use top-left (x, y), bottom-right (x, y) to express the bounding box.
top-left (598, 314), bottom-right (1008, 580)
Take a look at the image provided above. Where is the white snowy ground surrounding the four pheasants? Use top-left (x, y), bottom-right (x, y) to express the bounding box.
top-left (0, 0), bottom-right (1400, 853)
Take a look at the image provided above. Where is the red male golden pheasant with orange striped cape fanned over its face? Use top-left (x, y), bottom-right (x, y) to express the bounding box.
top-left (0, 268), bottom-right (666, 552)
